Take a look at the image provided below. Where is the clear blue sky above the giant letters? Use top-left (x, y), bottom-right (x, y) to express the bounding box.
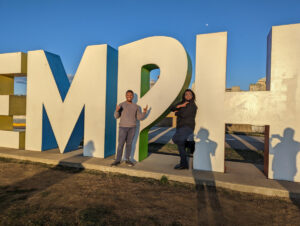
top-left (0, 0), bottom-right (300, 93)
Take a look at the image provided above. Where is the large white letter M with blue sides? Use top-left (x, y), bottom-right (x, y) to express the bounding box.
top-left (26, 45), bottom-right (117, 158)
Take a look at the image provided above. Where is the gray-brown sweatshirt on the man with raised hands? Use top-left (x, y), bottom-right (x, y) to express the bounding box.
top-left (114, 101), bottom-right (146, 127)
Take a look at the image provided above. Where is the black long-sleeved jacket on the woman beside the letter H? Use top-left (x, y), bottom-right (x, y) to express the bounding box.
top-left (171, 102), bottom-right (197, 130)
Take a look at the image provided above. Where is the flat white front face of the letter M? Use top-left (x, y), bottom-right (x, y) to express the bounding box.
top-left (26, 45), bottom-right (116, 158)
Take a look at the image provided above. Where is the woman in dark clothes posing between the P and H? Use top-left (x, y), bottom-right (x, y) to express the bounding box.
top-left (171, 89), bottom-right (197, 169)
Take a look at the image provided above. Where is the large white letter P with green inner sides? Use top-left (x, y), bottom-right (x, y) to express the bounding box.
top-left (118, 37), bottom-right (192, 161)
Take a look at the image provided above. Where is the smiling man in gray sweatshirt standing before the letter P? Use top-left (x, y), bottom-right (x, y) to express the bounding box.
top-left (111, 90), bottom-right (148, 166)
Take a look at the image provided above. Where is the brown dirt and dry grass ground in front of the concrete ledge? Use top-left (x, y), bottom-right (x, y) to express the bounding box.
top-left (0, 159), bottom-right (300, 226)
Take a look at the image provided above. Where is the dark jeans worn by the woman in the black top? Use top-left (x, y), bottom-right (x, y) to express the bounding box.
top-left (172, 126), bottom-right (194, 167)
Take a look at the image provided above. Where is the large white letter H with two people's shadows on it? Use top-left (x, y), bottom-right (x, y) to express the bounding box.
top-left (194, 24), bottom-right (300, 181)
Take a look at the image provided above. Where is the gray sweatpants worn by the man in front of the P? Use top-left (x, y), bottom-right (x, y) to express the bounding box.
top-left (116, 127), bottom-right (136, 161)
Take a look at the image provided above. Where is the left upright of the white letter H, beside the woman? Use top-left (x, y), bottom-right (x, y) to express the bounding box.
top-left (193, 32), bottom-right (227, 172)
